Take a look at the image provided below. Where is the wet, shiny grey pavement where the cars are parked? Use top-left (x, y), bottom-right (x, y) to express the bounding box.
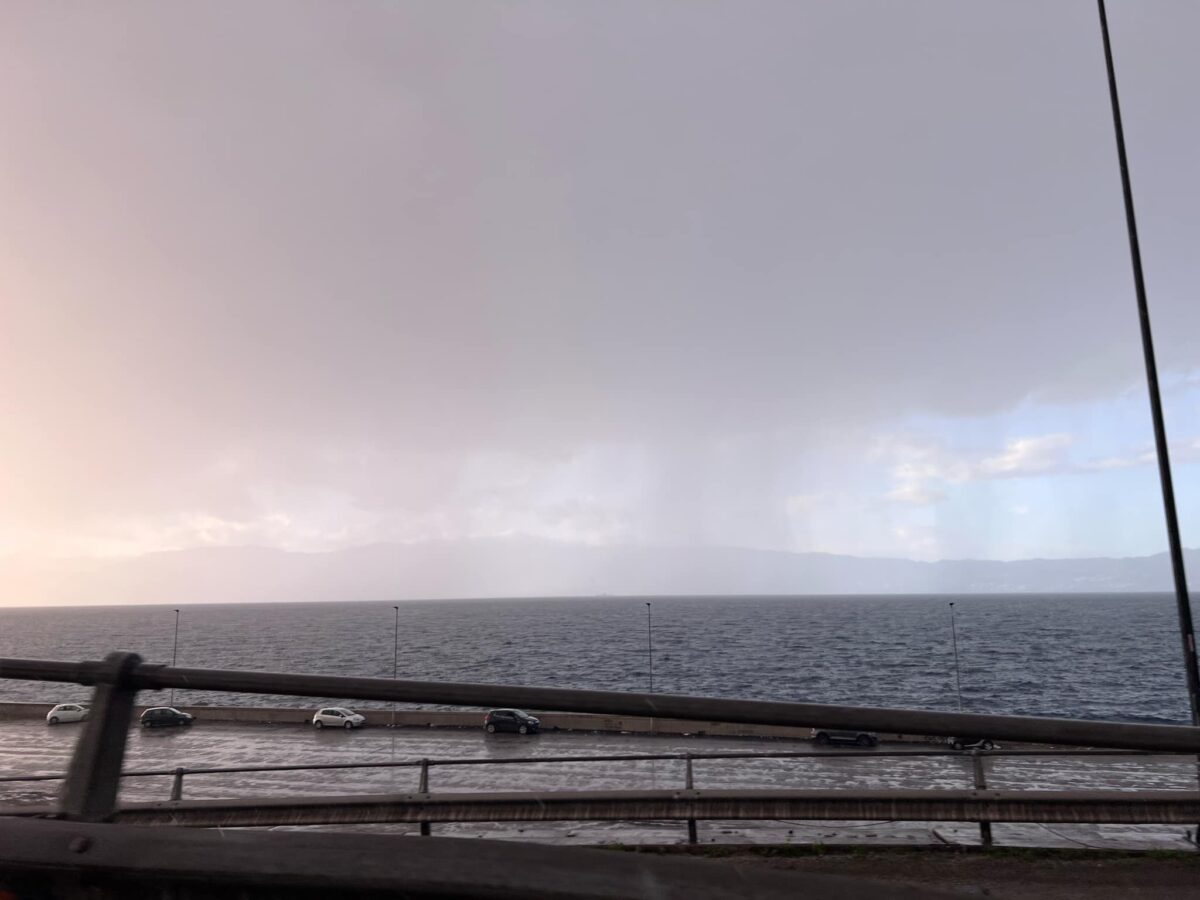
top-left (0, 720), bottom-right (1196, 850)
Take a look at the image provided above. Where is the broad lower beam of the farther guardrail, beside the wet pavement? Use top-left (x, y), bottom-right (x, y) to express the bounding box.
top-left (8, 790), bottom-right (1200, 828)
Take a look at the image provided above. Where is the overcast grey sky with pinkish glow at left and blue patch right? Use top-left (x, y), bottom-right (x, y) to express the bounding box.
top-left (0, 0), bottom-right (1200, 559)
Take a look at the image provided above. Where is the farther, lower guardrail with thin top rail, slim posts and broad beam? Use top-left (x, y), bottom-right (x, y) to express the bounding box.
top-left (0, 749), bottom-right (1200, 846)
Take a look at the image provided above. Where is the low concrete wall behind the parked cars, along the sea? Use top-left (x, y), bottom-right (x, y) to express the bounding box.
top-left (0, 702), bottom-right (926, 740)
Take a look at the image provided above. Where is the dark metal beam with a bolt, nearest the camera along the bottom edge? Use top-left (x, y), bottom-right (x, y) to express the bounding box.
top-left (0, 820), bottom-right (950, 900)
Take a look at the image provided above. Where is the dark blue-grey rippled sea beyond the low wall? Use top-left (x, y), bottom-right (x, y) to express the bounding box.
top-left (0, 594), bottom-right (1187, 722)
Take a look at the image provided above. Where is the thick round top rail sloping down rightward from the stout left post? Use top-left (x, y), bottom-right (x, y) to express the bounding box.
top-left (0, 659), bottom-right (1200, 752)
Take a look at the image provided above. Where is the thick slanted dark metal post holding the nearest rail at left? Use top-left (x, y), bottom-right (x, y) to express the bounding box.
top-left (61, 650), bottom-right (142, 822)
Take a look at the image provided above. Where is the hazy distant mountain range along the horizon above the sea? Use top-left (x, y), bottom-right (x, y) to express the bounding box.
top-left (0, 538), bottom-right (1200, 606)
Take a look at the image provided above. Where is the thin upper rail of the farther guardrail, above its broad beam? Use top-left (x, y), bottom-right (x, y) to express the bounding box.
top-left (0, 749), bottom-right (1192, 784)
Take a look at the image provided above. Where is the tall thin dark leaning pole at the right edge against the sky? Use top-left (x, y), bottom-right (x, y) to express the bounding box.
top-left (1096, 0), bottom-right (1200, 726)
